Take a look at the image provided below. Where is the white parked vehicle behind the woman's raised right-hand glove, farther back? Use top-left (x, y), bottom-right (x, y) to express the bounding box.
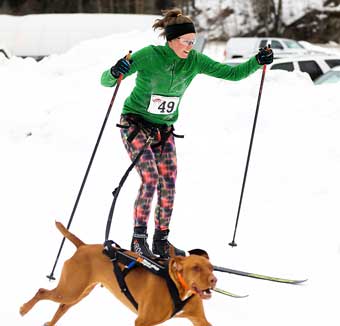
top-left (225, 37), bottom-right (309, 59)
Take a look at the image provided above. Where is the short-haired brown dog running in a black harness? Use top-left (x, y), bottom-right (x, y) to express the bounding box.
top-left (20, 222), bottom-right (217, 326)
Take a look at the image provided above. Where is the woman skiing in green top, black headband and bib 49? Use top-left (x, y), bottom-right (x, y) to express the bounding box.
top-left (101, 8), bottom-right (273, 258)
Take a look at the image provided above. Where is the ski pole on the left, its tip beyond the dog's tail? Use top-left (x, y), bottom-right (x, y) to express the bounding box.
top-left (46, 51), bottom-right (132, 280)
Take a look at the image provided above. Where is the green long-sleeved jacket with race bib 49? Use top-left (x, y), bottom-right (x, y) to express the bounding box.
top-left (101, 43), bottom-right (261, 125)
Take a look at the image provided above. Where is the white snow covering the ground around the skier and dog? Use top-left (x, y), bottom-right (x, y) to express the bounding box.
top-left (0, 14), bottom-right (340, 326)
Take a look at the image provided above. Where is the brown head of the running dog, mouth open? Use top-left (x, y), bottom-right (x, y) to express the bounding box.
top-left (169, 255), bottom-right (217, 299)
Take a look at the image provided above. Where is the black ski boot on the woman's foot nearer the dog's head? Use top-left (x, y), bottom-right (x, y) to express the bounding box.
top-left (152, 230), bottom-right (185, 259)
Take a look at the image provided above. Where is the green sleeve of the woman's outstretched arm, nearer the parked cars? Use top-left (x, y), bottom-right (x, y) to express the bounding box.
top-left (198, 53), bottom-right (261, 81)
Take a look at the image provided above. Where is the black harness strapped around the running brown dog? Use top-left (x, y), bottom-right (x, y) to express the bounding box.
top-left (103, 240), bottom-right (194, 317)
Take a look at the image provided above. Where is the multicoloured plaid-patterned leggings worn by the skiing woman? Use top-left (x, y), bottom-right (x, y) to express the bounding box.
top-left (120, 116), bottom-right (177, 230)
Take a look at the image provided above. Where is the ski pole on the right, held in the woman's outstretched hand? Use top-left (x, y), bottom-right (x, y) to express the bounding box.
top-left (229, 65), bottom-right (267, 247)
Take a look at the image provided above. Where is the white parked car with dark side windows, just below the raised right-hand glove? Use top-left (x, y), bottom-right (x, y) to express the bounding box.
top-left (226, 55), bottom-right (340, 80)
